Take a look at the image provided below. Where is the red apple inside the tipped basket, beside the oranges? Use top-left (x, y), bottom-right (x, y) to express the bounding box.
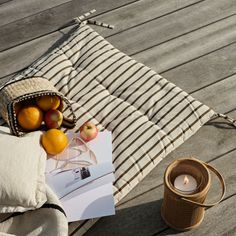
top-left (44, 110), bottom-right (63, 129)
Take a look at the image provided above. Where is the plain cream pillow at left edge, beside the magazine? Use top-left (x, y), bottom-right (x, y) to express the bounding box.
top-left (0, 126), bottom-right (47, 213)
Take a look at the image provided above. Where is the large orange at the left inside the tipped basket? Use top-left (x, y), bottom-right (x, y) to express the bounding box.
top-left (17, 105), bottom-right (43, 130)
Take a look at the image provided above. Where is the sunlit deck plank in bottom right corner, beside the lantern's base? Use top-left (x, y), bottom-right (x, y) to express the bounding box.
top-left (157, 195), bottom-right (236, 236)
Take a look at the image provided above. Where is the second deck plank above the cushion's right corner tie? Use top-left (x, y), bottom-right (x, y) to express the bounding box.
top-left (161, 43), bottom-right (236, 93)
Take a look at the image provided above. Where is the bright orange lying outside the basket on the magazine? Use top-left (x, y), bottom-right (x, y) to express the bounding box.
top-left (41, 129), bottom-right (68, 155)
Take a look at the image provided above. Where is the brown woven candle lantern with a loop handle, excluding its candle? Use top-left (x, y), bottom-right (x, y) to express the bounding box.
top-left (161, 158), bottom-right (225, 231)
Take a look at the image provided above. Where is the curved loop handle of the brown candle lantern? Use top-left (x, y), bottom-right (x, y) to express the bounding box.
top-left (181, 162), bottom-right (226, 207)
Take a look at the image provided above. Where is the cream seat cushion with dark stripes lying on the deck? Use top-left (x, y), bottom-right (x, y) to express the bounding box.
top-left (12, 25), bottom-right (215, 232)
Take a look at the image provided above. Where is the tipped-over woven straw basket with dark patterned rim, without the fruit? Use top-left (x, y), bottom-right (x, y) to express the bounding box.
top-left (0, 77), bottom-right (76, 136)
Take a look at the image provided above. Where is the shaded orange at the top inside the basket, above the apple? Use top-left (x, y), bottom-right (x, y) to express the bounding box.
top-left (36, 95), bottom-right (61, 111)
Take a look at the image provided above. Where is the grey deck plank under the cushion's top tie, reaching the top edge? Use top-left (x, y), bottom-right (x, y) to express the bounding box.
top-left (88, 0), bottom-right (205, 37)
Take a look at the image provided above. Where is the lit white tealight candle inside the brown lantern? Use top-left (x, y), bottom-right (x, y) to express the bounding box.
top-left (174, 174), bottom-right (197, 194)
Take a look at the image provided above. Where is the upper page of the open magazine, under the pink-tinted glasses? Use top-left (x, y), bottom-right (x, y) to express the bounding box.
top-left (46, 133), bottom-right (114, 199)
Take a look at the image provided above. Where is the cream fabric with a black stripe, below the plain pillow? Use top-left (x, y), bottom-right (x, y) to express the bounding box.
top-left (0, 186), bottom-right (68, 236)
